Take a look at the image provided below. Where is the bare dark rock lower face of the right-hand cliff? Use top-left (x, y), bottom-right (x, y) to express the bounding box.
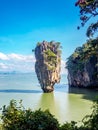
top-left (68, 57), bottom-right (98, 88)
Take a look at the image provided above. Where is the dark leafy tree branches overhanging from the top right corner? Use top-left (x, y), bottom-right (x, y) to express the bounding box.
top-left (75, 0), bottom-right (98, 37)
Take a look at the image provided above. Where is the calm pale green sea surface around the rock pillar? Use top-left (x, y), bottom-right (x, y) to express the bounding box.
top-left (0, 74), bottom-right (98, 123)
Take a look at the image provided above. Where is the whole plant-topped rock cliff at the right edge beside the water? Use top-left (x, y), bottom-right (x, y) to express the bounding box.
top-left (67, 39), bottom-right (98, 88)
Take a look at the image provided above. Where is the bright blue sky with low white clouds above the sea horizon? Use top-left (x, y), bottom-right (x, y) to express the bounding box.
top-left (0, 0), bottom-right (87, 71)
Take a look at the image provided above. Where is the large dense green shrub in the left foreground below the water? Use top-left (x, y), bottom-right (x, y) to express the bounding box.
top-left (2, 100), bottom-right (59, 130)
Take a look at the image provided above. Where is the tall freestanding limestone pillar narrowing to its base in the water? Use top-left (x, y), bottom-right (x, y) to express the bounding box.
top-left (35, 41), bottom-right (61, 92)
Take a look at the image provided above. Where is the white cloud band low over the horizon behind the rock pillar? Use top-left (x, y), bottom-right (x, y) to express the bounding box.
top-left (0, 52), bottom-right (67, 74)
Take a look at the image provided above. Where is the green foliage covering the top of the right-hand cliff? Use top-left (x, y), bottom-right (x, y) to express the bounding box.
top-left (67, 38), bottom-right (98, 73)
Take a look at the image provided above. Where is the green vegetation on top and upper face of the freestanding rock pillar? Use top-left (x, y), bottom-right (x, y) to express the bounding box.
top-left (36, 41), bottom-right (62, 70)
